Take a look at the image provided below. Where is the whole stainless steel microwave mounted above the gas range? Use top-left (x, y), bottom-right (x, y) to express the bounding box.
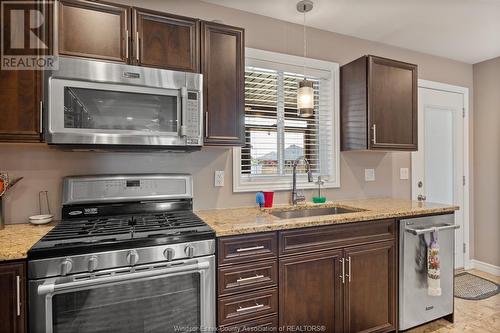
top-left (43, 57), bottom-right (203, 150)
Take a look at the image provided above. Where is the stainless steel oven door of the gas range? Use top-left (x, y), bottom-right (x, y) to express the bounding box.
top-left (30, 256), bottom-right (215, 333)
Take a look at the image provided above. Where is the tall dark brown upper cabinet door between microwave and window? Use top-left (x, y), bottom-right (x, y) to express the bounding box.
top-left (201, 22), bottom-right (245, 146)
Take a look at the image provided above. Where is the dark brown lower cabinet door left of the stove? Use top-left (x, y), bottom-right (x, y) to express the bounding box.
top-left (0, 263), bottom-right (26, 333)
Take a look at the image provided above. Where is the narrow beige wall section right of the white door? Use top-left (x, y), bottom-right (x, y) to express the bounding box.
top-left (474, 57), bottom-right (500, 267)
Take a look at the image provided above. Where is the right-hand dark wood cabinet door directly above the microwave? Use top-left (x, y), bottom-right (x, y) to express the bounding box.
top-left (133, 8), bottom-right (200, 72)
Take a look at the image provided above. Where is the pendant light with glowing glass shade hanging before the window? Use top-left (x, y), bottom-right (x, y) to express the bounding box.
top-left (297, 0), bottom-right (314, 117)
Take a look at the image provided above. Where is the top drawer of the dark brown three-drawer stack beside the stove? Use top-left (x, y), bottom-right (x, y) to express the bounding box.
top-left (218, 232), bottom-right (277, 265)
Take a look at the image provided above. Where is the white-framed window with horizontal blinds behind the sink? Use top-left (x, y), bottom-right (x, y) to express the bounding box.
top-left (233, 48), bottom-right (339, 192)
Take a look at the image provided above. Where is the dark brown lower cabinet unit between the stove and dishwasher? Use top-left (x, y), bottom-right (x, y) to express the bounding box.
top-left (218, 219), bottom-right (398, 333)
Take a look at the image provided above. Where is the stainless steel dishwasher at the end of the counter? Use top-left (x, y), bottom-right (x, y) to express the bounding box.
top-left (399, 214), bottom-right (459, 330)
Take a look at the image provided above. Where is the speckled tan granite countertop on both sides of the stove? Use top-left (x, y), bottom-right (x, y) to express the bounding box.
top-left (0, 198), bottom-right (459, 261)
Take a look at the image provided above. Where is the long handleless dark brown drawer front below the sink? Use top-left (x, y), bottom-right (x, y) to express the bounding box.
top-left (279, 219), bottom-right (396, 255)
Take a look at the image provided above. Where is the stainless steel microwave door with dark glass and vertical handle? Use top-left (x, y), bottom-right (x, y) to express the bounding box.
top-left (46, 78), bottom-right (192, 146)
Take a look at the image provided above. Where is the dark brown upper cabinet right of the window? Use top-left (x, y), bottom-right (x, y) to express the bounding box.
top-left (340, 55), bottom-right (418, 151)
